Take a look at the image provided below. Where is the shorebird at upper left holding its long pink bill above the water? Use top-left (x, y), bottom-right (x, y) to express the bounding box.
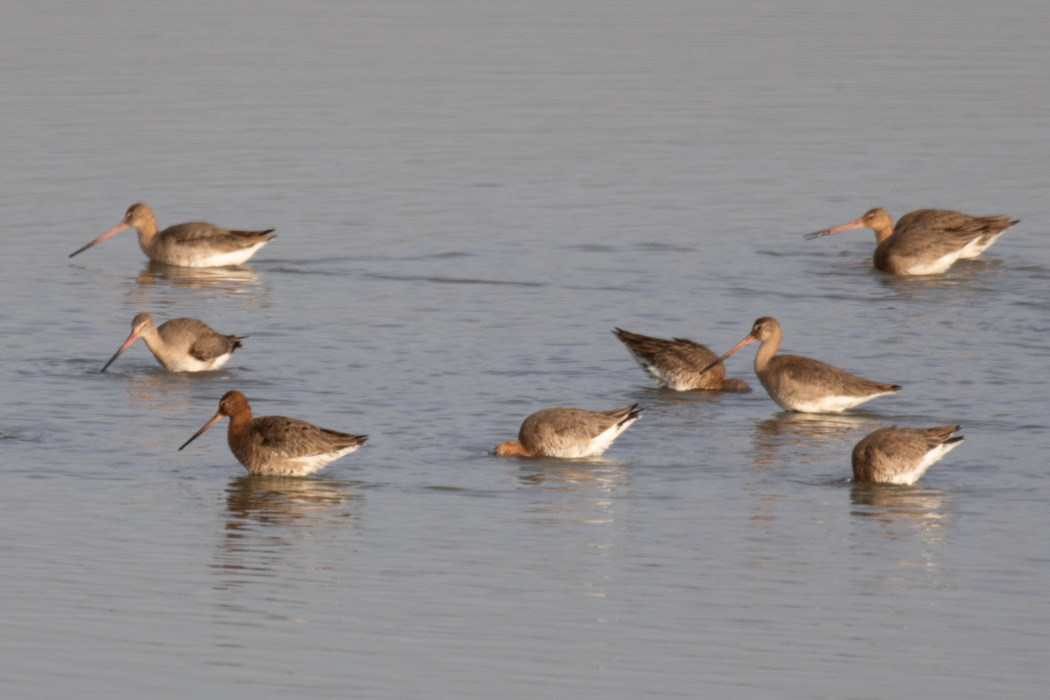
top-left (69, 204), bottom-right (275, 268)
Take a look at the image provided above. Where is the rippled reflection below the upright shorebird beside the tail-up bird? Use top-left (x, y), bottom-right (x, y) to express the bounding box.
top-left (752, 411), bottom-right (885, 471)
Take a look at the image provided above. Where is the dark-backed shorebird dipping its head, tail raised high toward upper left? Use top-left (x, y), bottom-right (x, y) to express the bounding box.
top-left (612, 328), bottom-right (751, 391)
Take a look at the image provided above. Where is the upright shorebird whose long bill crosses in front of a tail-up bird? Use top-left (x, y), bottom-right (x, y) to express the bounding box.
top-left (702, 316), bottom-right (901, 413)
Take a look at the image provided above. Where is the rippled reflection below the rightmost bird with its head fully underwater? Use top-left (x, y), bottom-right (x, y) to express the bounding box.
top-left (849, 484), bottom-right (948, 543)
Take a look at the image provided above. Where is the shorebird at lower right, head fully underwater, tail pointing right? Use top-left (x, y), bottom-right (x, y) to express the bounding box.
top-left (853, 425), bottom-right (963, 484)
